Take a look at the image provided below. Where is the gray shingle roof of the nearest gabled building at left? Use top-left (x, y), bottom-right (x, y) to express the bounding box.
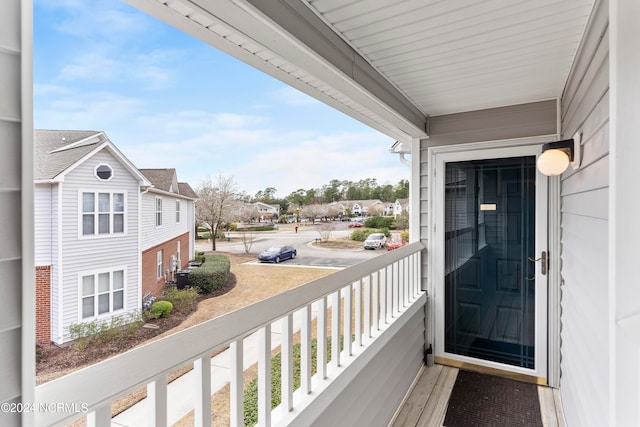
top-left (34, 130), bottom-right (107, 180)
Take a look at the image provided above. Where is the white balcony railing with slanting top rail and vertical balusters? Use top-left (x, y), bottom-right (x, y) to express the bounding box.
top-left (35, 243), bottom-right (424, 426)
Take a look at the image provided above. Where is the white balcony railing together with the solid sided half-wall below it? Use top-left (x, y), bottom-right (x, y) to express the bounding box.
top-left (35, 243), bottom-right (426, 426)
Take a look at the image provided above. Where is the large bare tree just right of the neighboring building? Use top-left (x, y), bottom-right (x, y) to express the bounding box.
top-left (196, 173), bottom-right (237, 251)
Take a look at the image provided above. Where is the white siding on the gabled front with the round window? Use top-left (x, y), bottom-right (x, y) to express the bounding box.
top-left (52, 149), bottom-right (141, 342)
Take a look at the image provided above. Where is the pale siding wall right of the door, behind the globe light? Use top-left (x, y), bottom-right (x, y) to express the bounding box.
top-left (560, 1), bottom-right (610, 426)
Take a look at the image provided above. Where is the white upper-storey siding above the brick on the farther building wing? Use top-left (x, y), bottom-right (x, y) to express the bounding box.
top-left (140, 191), bottom-right (193, 251)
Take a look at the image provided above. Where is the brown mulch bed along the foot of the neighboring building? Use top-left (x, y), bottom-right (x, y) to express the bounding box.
top-left (36, 273), bottom-right (236, 384)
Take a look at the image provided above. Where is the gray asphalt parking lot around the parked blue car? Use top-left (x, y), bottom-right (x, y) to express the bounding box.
top-left (196, 222), bottom-right (385, 268)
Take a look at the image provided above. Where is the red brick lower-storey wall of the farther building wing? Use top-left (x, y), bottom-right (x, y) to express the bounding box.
top-left (142, 233), bottom-right (193, 297)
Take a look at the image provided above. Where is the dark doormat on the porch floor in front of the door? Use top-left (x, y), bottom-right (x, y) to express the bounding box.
top-left (443, 371), bottom-right (542, 427)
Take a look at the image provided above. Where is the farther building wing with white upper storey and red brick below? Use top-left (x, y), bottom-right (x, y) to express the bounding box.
top-left (140, 169), bottom-right (197, 297)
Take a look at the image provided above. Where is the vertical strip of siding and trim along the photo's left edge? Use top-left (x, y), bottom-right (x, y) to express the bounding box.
top-left (0, 0), bottom-right (28, 426)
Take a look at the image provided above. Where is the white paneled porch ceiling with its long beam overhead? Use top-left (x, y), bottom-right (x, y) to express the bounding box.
top-left (126, 0), bottom-right (595, 140)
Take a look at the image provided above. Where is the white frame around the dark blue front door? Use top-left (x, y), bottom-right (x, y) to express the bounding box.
top-left (427, 135), bottom-right (559, 384)
